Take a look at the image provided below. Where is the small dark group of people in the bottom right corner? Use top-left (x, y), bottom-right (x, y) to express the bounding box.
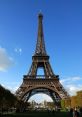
top-left (70, 107), bottom-right (82, 117)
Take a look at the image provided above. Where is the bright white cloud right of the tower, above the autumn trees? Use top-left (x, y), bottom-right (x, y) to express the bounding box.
top-left (60, 77), bottom-right (82, 96)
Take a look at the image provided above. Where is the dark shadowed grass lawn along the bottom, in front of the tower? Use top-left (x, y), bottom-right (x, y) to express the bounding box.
top-left (1, 111), bottom-right (72, 117)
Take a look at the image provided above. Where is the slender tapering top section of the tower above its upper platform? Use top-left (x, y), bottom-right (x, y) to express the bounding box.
top-left (35, 13), bottom-right (46, 55)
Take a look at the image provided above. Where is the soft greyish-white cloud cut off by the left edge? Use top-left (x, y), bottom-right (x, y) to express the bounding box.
top-left (0, 47), bottom-right (14, 71)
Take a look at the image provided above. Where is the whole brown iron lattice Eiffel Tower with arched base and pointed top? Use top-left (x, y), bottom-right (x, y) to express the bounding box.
top-left (16, 13), bottom-right (69, 103)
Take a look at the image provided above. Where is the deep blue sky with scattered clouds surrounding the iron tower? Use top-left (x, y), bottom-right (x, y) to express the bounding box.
top-left (0, 0), bottom-right (82, 102)
